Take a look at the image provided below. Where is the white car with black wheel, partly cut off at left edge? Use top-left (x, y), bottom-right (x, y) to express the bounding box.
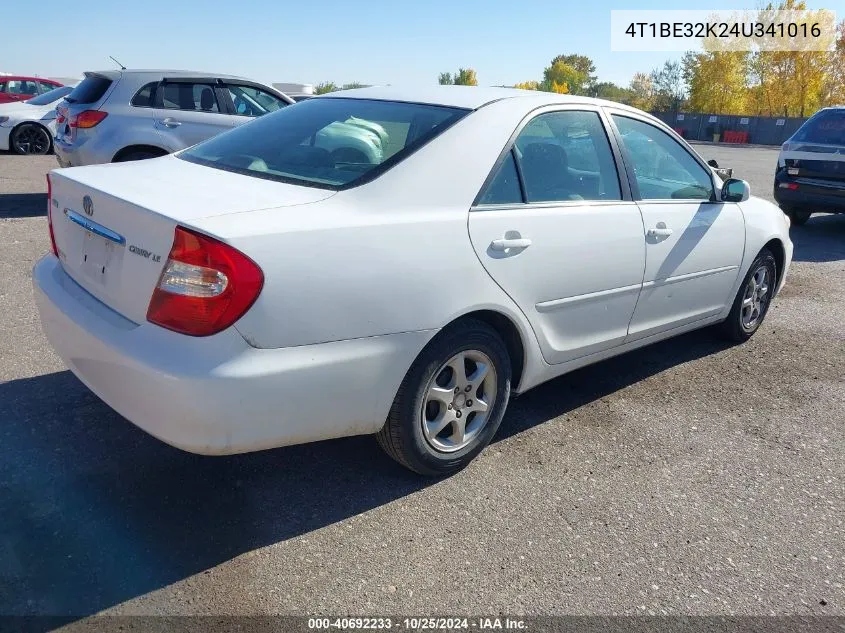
top-left (0, 86), bottom-right (73, 154)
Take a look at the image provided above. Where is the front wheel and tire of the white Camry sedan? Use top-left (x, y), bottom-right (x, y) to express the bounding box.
top-left (720, 248), bottom-right (777, 343)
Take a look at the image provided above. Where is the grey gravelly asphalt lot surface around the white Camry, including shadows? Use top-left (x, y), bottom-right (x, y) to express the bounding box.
top-left (0, 145), bottom-right (845, 616)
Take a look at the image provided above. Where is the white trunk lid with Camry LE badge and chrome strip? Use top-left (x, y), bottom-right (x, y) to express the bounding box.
top-left (50, 156), bottom-right (334, 323)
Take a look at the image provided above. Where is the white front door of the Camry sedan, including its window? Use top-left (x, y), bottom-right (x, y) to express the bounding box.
top-left (611, 111), bottom-right (745, 341)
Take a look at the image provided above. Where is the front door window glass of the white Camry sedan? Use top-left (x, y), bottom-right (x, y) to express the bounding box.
top-left (611, 114), bottom-right (713, 200)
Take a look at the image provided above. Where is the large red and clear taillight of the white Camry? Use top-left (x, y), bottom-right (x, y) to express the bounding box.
top-left (147, 226), bottom-right (264, 336)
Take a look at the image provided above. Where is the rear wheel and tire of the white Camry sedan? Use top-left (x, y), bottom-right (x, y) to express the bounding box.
top-left (376, 319), bottom-right (511, 476)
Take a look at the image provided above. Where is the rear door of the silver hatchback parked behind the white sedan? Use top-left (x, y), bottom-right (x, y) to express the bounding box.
top-left (153, 79), bottom-right (234, 151)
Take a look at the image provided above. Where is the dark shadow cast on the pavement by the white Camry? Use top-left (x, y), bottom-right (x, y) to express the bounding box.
top-left (0, 332), bottom-right (725, 630)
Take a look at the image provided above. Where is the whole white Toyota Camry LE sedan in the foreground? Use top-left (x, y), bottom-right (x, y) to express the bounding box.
top-left (33, 86), bottom-right (792, 475)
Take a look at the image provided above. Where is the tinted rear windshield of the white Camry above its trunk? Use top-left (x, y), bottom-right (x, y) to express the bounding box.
top-left (178, 98), bottom-right (469, 189)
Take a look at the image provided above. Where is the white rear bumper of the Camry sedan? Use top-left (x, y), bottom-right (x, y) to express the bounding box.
top-left (33, 255), bottom-right (434, 454)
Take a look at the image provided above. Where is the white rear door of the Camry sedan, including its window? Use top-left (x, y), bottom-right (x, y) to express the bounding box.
top-left (469, 106), bottom-right (645, 363)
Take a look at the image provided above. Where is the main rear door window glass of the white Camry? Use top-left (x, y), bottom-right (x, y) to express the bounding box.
top-left (514, 110), bottom-right (622, 202)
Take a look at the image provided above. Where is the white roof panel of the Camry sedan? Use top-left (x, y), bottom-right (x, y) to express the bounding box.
top-left (320, 85), bottom-right (640, 112)
